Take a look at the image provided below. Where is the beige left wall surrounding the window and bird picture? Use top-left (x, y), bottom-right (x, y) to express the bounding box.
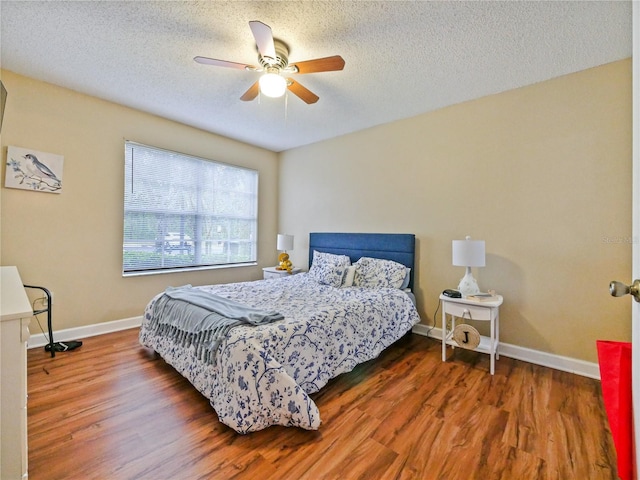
top-left (0, 71), bottom-right (278, 333)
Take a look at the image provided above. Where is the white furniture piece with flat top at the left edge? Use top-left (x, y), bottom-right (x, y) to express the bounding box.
top-left (0, 267), bottom-right (33, 480)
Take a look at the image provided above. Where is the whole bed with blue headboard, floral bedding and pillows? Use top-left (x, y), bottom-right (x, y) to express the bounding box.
top-left (140, 233), bottom-right (420, 434)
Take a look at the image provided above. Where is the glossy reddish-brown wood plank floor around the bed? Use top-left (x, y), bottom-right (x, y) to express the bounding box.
top-left (28, 329), bottom-right (617, 480)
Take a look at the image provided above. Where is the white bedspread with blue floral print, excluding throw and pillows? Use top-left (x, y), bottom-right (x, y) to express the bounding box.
top-left (140, 273), bottom-right (420, 433)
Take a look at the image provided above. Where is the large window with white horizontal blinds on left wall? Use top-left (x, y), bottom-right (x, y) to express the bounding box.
top-left (122, 142), bottom-right (258, 275)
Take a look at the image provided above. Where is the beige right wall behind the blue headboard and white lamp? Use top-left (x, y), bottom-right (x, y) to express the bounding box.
top-left (280, 59), bottom-right (631, 362)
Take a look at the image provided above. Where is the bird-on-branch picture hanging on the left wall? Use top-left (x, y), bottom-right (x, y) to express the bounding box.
top-left (4, 146), bottom-right (64, 193)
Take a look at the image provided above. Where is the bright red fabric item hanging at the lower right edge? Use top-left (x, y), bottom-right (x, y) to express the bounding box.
top-left (596, 340), bottom-right (634, 480)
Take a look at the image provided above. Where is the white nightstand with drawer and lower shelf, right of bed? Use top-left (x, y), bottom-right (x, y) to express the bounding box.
top-left (440, 295), bottom-right (502, 375)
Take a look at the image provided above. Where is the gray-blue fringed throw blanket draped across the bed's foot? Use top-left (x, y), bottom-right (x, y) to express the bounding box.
top-left (149, 285), bottom-right (284, 365)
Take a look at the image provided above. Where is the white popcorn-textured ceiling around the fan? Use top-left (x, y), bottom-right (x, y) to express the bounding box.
top-left (0, 0), bottom-right (631, 151)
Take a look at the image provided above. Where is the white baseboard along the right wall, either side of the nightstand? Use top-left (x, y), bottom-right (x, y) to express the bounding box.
top-left (412, 323), bottom-right (600, 380)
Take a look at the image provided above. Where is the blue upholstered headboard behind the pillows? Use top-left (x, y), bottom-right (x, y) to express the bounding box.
top-left (309, 232), bottom-right (416, 289)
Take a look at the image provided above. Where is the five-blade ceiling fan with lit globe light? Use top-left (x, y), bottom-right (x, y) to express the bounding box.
top-left (194, 21), bottom-right (344, 104)
